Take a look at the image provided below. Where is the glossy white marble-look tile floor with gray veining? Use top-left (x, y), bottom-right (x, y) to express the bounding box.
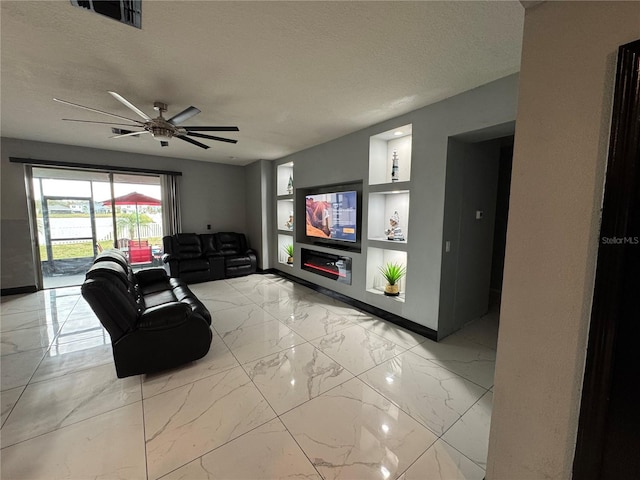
top-left (0, 275), bottom-right (498, 480)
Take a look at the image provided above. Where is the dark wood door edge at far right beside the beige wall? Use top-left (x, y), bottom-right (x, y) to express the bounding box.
top-left (573, 40), bottom-right (640, 480)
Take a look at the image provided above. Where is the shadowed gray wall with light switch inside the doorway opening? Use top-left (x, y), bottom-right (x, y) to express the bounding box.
top-left (438, 138), bottom-right (501, 337)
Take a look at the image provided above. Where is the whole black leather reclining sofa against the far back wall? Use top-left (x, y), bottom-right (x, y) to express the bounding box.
top-left (162, 232), bottom-right (258, 283)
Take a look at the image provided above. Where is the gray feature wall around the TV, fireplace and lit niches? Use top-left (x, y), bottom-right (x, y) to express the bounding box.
top-left (270, 75), bottom-right (518, 330)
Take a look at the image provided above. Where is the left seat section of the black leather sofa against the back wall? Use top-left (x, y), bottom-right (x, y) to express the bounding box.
top-left (162, 233), bottom-right (224, 283)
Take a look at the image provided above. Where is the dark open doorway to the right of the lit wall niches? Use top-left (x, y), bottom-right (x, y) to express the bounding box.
top-left (438, 132), bottom-right (513, 339)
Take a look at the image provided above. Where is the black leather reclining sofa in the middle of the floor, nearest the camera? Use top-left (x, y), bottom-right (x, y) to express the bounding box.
top-left (82, 250), bottom-right (212, 378)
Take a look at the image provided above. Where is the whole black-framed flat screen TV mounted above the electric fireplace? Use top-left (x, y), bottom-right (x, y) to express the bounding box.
top-left (296, 182), bottom-right (362, 251)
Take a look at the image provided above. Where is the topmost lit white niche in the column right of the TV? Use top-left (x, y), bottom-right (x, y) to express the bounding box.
top-left (369, 124), bottom-right (413, 185)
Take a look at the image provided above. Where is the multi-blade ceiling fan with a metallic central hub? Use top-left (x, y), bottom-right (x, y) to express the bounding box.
top-left (53, 92), bottom-right (239, 149)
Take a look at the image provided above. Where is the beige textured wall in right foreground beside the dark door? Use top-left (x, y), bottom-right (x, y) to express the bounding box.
top-left (487, 2), bottom-right (640, 480)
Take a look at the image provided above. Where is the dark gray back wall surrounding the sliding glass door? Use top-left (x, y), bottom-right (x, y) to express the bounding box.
top-left (0, 138), bottom-right (246, 289)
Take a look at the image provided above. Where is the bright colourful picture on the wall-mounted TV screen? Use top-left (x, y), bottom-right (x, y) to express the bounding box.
top-left (305, 191), bottom-right (358, 242)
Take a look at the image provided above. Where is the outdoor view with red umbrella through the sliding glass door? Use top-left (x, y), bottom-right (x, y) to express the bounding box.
top-left (33, 168), bottom-right (163, 288)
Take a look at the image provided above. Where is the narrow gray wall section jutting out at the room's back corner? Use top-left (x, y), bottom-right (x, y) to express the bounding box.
top-left (244, 160), bottom-right (272, 270)
